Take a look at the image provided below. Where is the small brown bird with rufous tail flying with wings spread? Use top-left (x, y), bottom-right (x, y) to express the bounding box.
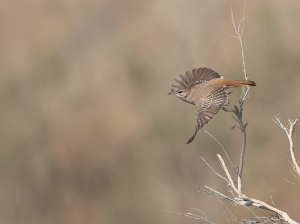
top-left (168, 67), bottom-right (256, 144)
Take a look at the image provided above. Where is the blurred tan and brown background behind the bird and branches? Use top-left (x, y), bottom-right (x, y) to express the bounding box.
top-left (0, 0), bottom-right (300, 224)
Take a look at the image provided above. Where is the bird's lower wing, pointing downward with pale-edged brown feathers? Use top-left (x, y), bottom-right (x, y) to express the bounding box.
top-left (187, 86), bottom-right (228, 144)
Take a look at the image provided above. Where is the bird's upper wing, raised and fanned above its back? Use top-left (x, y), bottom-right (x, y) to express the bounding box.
top-left (172, 68), bottom-right (222, 89)
